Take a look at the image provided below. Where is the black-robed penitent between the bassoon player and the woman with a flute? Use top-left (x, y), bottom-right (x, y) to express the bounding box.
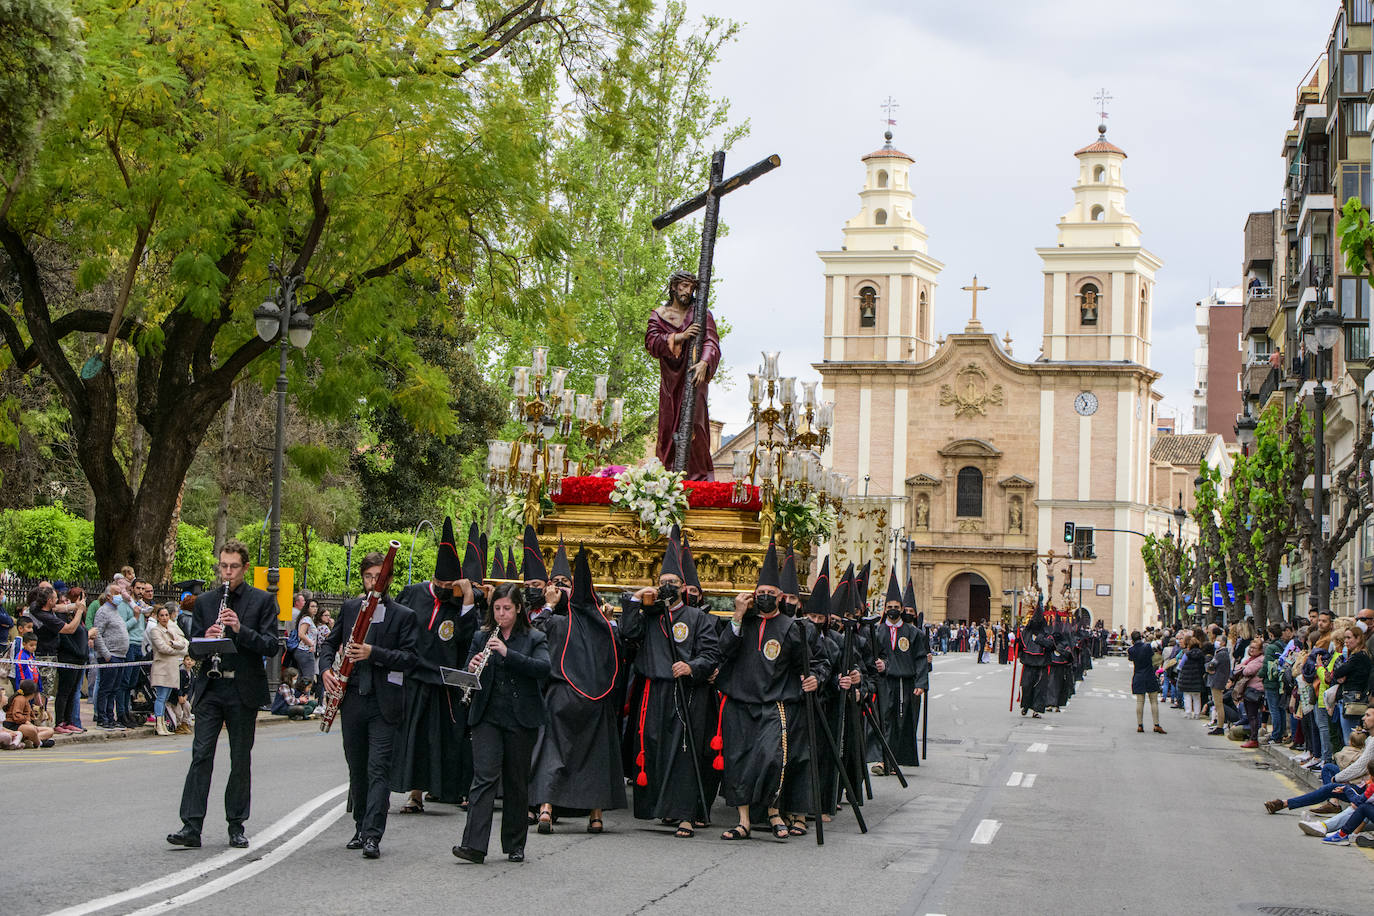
top-left (392, 582), bottom-right (481, 805)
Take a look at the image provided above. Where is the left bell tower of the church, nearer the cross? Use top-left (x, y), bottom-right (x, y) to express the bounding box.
top-left (816, 130), bottom-right (944, 364)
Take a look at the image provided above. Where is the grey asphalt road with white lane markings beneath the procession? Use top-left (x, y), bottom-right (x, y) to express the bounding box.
top-left (10, 655), bottom-right (1374, 916)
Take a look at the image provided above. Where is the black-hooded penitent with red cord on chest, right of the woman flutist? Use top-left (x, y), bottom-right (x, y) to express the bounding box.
top-left (529, 602), bottom-right (625, 812)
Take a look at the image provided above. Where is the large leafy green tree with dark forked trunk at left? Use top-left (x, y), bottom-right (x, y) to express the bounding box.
top-left (0, 0), bottom-right (651, 578)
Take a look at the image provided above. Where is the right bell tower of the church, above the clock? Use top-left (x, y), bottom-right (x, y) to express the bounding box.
top-left (1036, 124), bottom-right (1164, 365)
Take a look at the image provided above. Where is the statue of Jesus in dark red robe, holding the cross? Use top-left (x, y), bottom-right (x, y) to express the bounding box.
top-left (644, 271), bottom-right (720, 481)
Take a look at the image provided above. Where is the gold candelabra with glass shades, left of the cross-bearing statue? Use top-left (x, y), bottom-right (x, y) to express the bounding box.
top-left (486, 346), bottom-right (625, 525)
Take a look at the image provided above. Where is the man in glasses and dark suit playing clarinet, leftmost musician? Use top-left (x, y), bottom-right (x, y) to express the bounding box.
top-left (168, 540), bottom-right (280, 849)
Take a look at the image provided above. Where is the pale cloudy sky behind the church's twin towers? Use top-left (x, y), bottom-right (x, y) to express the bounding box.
top-left (687, 0), bottom-right (1340, 431)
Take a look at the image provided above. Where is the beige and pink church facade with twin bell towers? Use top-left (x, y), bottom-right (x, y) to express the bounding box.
top-left (815, 128), bottom-right (1162, 637)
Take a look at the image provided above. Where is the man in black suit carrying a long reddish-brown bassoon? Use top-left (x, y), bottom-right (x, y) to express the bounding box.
top-left (320, 553), bottom-right (419, 858)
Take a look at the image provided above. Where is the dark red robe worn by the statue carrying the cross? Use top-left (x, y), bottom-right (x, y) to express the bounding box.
top-left (644, 309), bottom-right (720, 481)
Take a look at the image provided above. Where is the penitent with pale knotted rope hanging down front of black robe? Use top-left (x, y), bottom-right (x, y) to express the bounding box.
top-left (717, 614), bottom-right (802, 820)
